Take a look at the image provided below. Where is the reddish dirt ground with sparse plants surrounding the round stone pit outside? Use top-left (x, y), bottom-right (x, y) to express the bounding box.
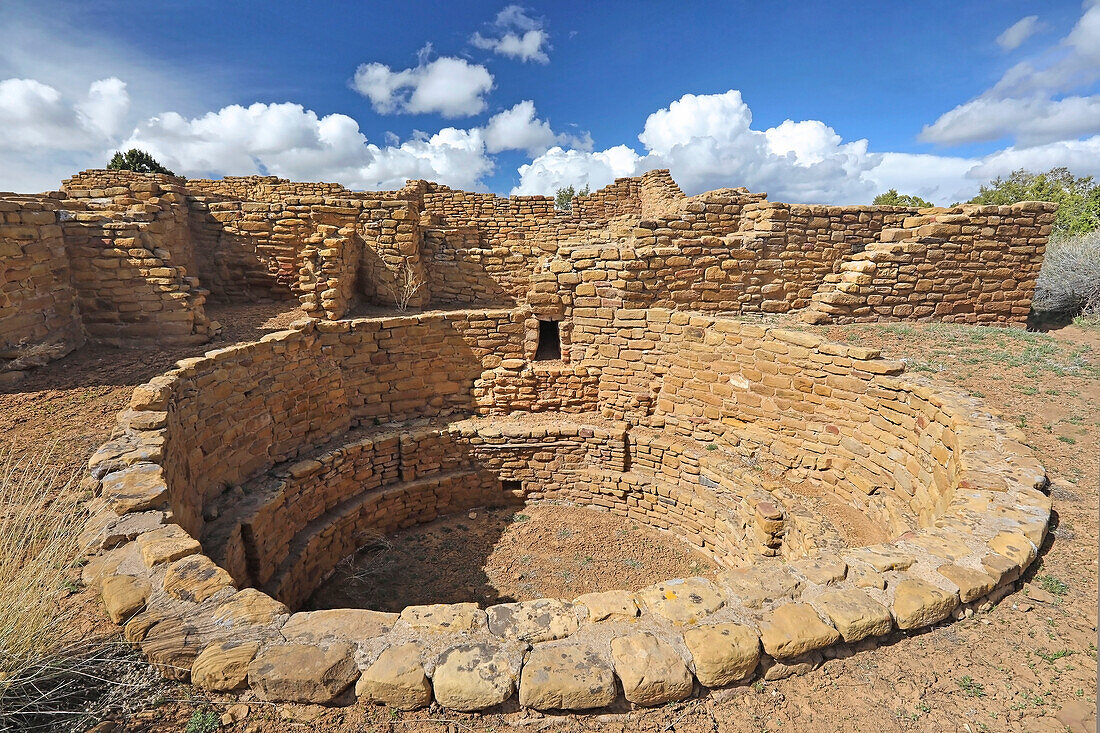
top-left (0, 306), bottom-right (1100, 733)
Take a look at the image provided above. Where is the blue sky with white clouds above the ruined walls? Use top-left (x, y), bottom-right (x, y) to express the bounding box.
top-left (0, 0), bottom-right (1100, 204)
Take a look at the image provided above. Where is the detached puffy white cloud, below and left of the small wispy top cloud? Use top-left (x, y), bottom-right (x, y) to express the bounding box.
top-left (352, 56), bottom-right (493, 118)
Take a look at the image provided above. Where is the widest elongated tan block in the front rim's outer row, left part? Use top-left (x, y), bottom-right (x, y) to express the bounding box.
top-left (249, 643), bottom-right (359, 704)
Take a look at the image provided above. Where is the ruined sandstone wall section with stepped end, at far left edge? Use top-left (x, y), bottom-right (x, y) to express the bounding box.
top-left (0, 172), bottom-right (213, 376)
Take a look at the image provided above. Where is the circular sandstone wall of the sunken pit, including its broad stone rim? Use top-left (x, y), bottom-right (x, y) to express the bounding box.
top-left (85, 304), bottom-right (1051, 710)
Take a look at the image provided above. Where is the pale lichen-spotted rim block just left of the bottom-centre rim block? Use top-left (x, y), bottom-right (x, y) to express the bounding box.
top-left (431, 643), bottom-right (516, 712)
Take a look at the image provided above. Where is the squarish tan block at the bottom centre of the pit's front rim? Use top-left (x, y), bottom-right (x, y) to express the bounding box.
top-left (519, 645), bottom-right (617, 710)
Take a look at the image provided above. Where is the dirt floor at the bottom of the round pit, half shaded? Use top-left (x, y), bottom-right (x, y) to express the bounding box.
top-left (307, 503), bottom-right (716, 612)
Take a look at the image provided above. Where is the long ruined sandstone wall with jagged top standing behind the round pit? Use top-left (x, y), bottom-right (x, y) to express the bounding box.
top-left (0, 171), bottom-right (1052, 370)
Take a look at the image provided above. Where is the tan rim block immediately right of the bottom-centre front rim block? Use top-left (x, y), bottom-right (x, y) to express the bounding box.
top-left (612, 634), bottom-right (694, 705)
